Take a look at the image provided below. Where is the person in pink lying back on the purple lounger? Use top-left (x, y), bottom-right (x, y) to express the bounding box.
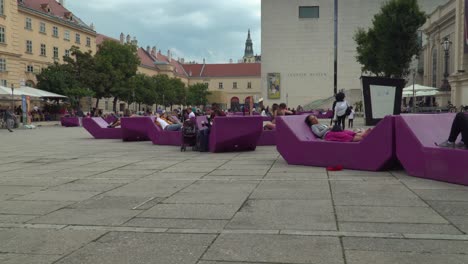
top-left (305, 115), bottom-right (372, 142)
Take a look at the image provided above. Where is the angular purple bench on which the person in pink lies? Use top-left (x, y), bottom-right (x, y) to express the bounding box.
top-left (276, 115), bottom-right (395, 171)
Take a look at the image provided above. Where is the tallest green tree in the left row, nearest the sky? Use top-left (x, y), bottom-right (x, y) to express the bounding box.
top-left (95, 40), bottom-right (140, 111)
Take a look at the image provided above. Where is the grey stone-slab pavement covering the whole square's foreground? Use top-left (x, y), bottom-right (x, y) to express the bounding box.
top-left (0, 127), bottom-right (468, 264)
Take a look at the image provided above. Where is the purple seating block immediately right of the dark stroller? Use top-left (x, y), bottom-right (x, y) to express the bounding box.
top-left (209, 116), bottom-right (263, 152)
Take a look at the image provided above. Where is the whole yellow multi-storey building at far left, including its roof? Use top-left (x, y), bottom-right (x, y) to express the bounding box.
top-left (0, 0), bottom-right (96, 87)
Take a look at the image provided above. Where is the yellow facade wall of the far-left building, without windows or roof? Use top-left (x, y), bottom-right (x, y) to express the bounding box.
top-left (0, 0), bottom-right (96, 87)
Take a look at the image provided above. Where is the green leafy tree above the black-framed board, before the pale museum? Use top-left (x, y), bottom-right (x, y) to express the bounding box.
top-left (354, 0), bottom-right (426, 78)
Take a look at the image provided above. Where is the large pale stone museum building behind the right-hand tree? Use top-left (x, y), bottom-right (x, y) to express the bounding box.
top-left (262, 0), bottom-right (445, 107)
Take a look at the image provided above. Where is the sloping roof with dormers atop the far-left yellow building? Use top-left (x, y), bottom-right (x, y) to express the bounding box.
top-left (19, 0), bottom-right (92, 30)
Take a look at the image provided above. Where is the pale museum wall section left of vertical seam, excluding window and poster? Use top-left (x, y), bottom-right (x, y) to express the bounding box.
top-left (261, 0), bottom-right (334, 107)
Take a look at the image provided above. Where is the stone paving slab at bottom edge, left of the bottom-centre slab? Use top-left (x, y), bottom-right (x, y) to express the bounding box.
top-left (57, 233), bottom-right (216, 264)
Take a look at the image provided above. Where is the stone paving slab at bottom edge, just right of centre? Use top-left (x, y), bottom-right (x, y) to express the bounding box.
top-left (202, 234), bottom-right (344, 264)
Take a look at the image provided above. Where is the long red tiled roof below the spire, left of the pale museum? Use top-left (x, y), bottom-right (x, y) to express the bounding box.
top-left (184, 63), bottom-right (261, 77)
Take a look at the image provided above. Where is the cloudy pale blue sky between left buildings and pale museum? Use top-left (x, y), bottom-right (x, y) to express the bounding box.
top-left (65, 0), bottom-right (261, 63)
